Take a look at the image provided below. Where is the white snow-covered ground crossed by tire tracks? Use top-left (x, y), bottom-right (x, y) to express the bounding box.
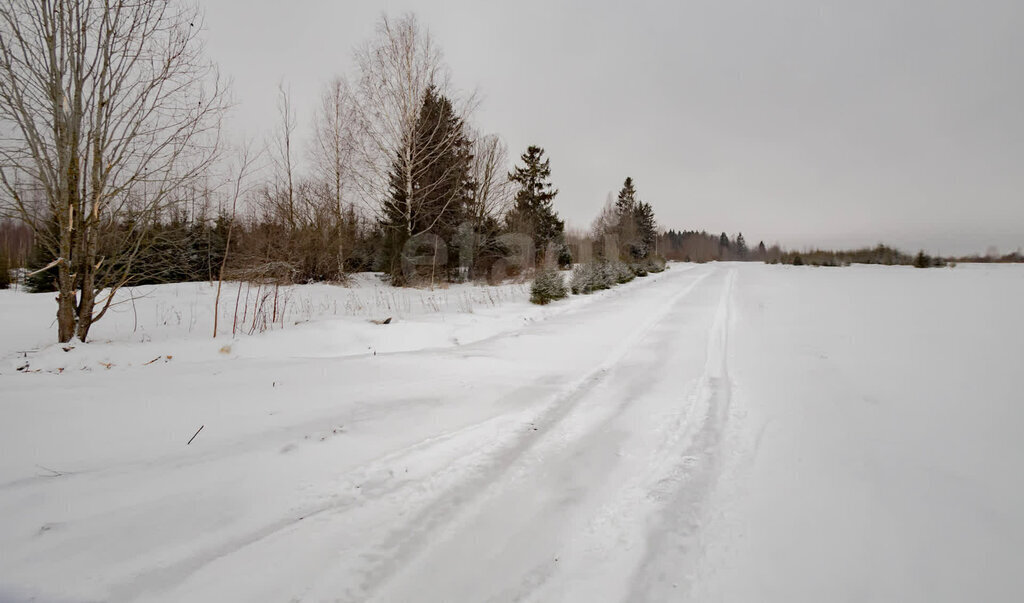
top-left (0, 264), bottom-right (1024, 602)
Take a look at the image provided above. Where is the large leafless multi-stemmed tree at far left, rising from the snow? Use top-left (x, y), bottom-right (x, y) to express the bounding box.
top-left (0, 0), bottom-right (226, 342)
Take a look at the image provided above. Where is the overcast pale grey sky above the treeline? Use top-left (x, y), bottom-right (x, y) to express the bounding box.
top-left (200, 0), bottom-right (1024, 253)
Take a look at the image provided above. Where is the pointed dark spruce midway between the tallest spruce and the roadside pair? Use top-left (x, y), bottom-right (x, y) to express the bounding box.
top-left (506, 144), bottom-right (571, 264)
